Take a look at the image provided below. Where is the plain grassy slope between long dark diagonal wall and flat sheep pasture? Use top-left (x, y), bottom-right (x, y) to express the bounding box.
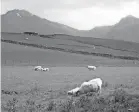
top-left (1, 42), bottom-right (138, 66)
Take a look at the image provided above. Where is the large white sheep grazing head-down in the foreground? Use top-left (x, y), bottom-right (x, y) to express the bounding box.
top-left (68, 78), bottom-right (102, 96)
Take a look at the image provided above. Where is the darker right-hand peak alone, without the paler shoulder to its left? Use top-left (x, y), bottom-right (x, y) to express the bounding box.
top-left (104, 16), bottom-right (139, 42)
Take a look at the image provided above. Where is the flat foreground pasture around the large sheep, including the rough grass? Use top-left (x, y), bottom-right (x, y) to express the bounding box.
top-left (1, 66), bottom-right (139, 112)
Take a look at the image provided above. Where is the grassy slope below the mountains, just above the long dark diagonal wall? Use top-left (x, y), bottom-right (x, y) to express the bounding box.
top-left (2, 33), bottom-right (139, 60)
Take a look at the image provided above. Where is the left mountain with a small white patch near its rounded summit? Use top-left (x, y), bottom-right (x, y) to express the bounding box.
top-left (1, 9), bottom-right (77, 35)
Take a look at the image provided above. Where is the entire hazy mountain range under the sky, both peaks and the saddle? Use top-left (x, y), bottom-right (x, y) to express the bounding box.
top-left (1, 10), bottom-right (139, 43)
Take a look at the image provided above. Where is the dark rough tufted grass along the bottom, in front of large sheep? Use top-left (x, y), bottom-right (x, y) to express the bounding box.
top-left (2, 83), bottom-right (139, 112)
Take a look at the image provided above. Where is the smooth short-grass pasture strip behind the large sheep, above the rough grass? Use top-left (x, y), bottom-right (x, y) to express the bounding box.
top-left (1, 66), bottom-right (139, 91)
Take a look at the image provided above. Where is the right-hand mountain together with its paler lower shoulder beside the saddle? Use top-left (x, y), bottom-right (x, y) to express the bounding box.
top-left (86, 15), bottom-right (139, 42)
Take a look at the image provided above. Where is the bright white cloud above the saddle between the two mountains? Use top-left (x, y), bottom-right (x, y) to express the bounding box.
top-left (45, 2), bottom-right (139, 30)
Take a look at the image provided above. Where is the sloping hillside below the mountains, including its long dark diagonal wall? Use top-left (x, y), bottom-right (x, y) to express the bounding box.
top-left (2, 33), bottom-right (139, 60)
